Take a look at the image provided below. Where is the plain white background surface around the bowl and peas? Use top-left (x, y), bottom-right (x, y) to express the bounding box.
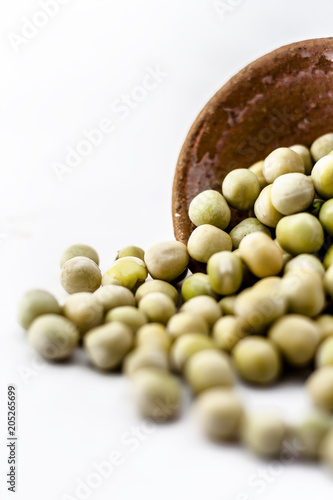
top-left (0, 0), bottom-right (333, 500)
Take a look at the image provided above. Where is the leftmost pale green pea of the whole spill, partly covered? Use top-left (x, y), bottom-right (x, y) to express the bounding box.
top-left (18, 290), bottom-right (61, 330)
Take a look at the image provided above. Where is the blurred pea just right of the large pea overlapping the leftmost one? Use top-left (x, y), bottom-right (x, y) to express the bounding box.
top-left (83, 321), bottom-right (133, 370)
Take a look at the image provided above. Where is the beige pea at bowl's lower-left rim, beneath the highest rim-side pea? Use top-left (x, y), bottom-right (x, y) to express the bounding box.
top-left (187, 224), bottom-right (232, 263)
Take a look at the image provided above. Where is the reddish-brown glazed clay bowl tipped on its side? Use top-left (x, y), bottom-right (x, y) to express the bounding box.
top-left (172, 38), bottom-right (333, 271)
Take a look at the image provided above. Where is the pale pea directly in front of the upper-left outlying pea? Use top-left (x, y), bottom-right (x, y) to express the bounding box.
top-left (60, 257), bottom-right (102, 293)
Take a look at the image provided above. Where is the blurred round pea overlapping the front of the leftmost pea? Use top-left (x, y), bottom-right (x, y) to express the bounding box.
top-left (27, 314), bottom-right (80, 361)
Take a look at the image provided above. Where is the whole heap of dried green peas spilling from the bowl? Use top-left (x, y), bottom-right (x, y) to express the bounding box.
top-left (18, 133), bottom-right (333, 467)
